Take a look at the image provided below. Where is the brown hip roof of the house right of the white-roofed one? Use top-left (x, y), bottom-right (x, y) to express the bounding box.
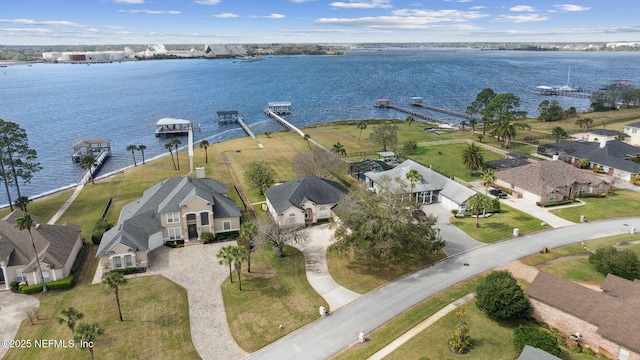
top-left (496, 160), bottom-right (607, 195)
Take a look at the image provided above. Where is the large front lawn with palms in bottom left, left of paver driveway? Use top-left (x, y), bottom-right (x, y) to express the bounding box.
top-left (4, 276), bottom-right (199, 360)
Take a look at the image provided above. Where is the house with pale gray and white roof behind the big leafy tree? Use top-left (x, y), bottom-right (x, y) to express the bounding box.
top-left (364, 160), bottom-right (476, 213)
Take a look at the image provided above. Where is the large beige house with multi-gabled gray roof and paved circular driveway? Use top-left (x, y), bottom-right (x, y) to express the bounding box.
top-left (97, 176), bottom-right (240, 273)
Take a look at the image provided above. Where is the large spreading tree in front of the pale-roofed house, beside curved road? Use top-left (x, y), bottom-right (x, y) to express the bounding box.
top-left (332, 177), bottom-right (444, 261)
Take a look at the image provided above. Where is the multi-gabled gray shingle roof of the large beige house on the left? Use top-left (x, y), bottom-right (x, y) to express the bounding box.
top-left (97, 176), bottom-right (240, 256)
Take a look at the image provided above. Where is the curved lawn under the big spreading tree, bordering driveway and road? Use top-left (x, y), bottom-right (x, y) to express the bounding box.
top-left (327, 247), bottom-right (445, 294)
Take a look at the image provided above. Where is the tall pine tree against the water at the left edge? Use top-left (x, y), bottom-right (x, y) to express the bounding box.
top-left (0, 119), bottom-right (42, 204)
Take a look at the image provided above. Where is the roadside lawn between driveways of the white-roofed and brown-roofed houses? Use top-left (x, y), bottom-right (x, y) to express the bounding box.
top-left (451, 204), bottom-right (547, 243)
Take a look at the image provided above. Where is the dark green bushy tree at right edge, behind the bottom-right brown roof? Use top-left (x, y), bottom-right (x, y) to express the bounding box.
top-left (589, 246), bottom-right (640, 280)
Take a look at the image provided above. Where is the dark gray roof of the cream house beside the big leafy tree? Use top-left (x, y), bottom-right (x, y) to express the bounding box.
top-left (265, 176), bottom-right (347, 214)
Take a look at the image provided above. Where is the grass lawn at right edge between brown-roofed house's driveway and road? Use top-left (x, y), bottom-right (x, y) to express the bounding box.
top-left (550, 189), bottom-right (640, 221)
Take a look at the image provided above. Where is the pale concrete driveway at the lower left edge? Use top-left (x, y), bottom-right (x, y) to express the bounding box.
top-left (0, 291), bottom-right (40, 358)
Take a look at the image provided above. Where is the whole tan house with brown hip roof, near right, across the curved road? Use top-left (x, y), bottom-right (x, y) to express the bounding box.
top-left (496, 160), bottom-right (610, 204)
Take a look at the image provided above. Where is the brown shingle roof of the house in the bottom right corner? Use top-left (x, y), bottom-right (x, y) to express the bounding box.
top-left (527, 271), bottom-right (640, 353)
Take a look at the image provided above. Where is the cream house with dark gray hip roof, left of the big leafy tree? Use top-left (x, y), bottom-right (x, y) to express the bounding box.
top-left (264, 176), bottom-right (347, 225)
